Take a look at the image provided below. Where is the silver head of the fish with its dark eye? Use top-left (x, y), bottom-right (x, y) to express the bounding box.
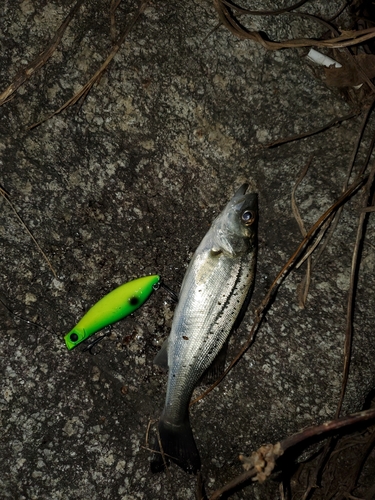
top-left (211, 184), bottom-right (258, 257)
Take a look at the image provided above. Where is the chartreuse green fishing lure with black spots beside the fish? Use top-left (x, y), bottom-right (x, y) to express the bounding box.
top-left (64, 274), bottom-right (160, 350)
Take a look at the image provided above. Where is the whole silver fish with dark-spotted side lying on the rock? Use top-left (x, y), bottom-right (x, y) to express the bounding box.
top-left (151, 184), bottom-right (258, 473)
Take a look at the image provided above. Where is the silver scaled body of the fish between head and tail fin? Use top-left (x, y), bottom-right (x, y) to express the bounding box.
top-left (163, 248), bottom-right (255, 424)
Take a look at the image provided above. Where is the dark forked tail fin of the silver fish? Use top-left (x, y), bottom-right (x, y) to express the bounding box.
top-left (151, 418), bottom-right (201, 474)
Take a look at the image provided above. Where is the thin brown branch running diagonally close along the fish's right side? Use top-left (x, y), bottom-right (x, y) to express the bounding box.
top-left (190, 172), bottom-right (368, 406)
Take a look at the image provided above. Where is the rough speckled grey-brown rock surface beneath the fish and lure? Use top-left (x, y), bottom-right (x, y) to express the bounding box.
top-left (0, 0), bottom-right (375, 500)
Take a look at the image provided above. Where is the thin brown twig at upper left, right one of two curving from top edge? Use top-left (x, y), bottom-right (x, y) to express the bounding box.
top-left (28, 0), bottom-right (150, 130)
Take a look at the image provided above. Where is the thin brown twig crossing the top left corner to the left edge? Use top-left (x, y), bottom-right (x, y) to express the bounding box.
top-left (0, 0), bottom-right (84, 106)
